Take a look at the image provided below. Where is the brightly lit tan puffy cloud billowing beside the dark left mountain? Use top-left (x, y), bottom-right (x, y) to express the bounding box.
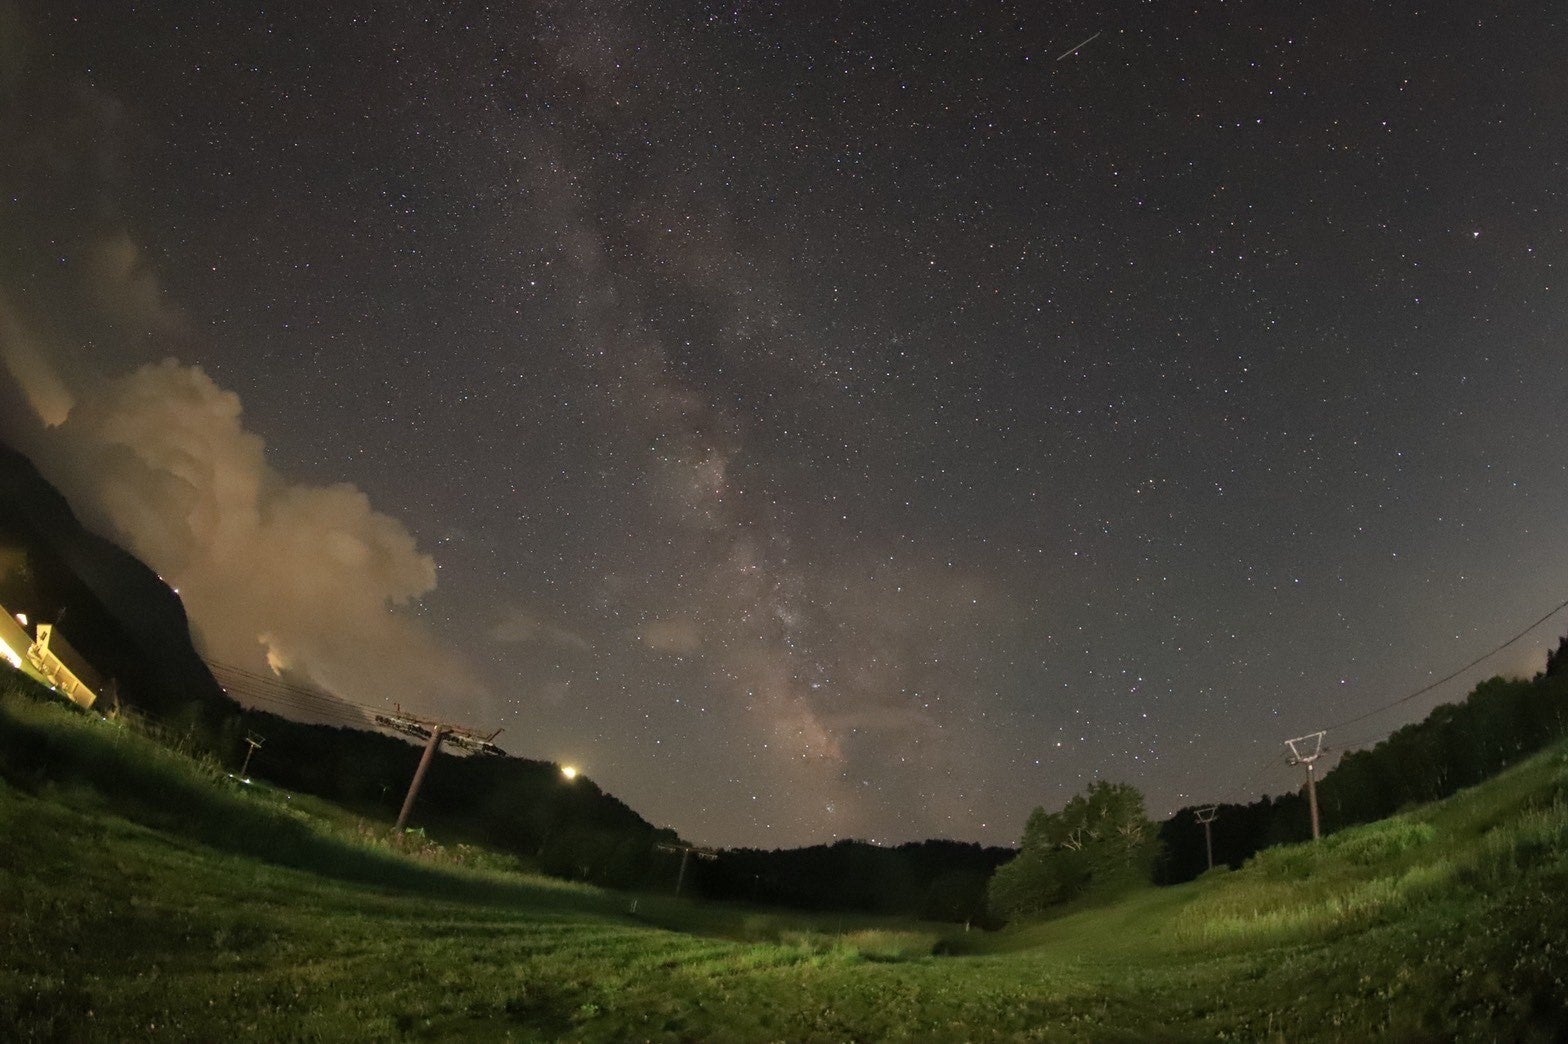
top-left (45, 359), bottom-right (481, 705)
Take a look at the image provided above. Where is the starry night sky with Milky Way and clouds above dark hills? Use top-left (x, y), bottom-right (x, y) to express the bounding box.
top-left (0, 0), bottom-right (1568, 846)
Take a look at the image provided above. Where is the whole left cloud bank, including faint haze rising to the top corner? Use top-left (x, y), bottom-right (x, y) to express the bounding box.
top-left (0, 26), bottom-right (483, 709)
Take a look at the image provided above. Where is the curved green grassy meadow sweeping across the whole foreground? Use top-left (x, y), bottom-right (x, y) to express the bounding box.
top-left (0, 694), bottom-right (1568, 1041)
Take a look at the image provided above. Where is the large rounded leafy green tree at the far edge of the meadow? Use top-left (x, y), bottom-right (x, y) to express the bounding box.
top-left (988, 779), bottom-right (1159, 917)
